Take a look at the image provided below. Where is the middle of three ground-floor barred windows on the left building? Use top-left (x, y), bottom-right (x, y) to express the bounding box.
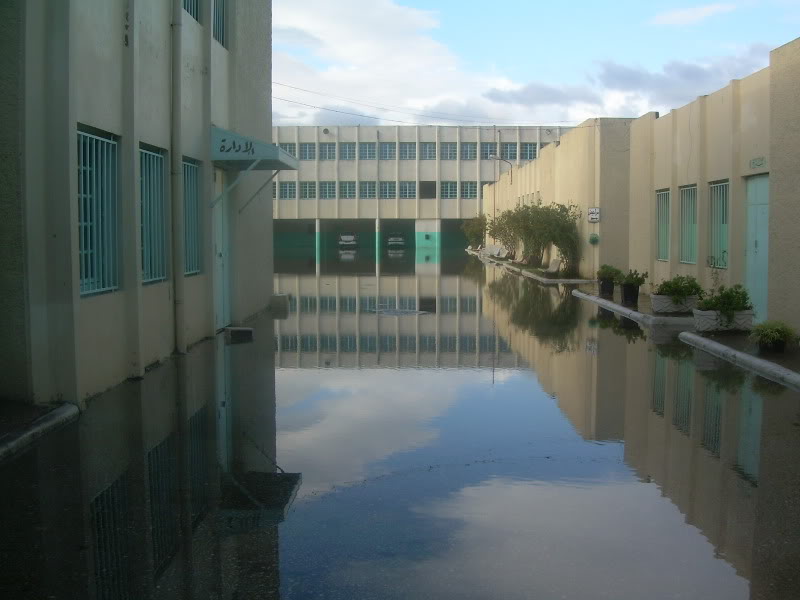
top-left (139, 149), bottom-right (167, 283)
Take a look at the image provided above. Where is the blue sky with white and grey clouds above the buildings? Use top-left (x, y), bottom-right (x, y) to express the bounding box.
top-left (272, 0), bottom-right (800, 125)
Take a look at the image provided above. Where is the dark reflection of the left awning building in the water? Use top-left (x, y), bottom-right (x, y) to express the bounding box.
top-left (0, 320), bottom-right (297, 599)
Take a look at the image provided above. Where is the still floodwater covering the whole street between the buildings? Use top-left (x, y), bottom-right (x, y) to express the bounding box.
top-left (0, 256), bottom-right (800, 600)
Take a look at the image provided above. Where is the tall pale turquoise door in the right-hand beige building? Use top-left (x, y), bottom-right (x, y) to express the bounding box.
top-left (745, 175), bottom-right (769, 322)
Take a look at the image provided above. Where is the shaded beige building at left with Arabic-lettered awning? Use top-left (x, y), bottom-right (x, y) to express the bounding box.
top-left (0, 0), bottom-right (296, 402)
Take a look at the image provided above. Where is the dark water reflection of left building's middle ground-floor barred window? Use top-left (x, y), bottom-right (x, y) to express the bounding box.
top-left (147, 433), bottom-right (178, 575)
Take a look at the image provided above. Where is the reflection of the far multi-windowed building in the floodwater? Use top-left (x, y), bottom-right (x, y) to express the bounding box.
top-left (274, 275), bottom-right (520, 368)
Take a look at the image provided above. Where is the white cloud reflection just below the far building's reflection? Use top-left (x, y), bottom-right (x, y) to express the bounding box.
top-left (276, 369), bottom-right (491, 495)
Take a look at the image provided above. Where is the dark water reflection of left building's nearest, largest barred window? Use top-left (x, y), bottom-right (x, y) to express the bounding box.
top-left (89, 472), bottom-right (130, 600)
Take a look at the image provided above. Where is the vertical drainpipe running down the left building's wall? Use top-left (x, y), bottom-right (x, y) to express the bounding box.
top-left (170, 0), bottom-right (186, 354)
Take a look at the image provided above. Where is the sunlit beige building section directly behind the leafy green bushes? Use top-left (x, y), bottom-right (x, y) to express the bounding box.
top-left (483, 119), bottom-right (632, 279)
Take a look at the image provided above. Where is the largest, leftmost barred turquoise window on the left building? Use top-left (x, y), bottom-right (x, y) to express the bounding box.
top-left (78, 132), bottom-right (119, 294)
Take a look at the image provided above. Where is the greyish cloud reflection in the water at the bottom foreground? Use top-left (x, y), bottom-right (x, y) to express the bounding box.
top-left (335, 479), bottom-right (749, 600)
